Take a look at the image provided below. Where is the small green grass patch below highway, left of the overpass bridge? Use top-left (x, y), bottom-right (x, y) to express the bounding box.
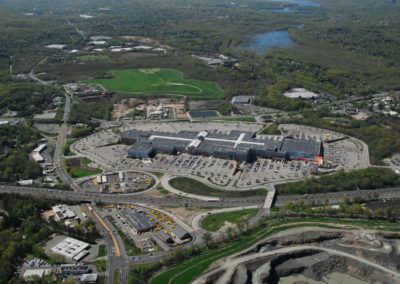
top-left (201, 209), bottom-right (258, 232)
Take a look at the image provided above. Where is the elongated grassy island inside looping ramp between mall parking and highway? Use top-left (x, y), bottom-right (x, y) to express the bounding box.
top-left (169, 177), bottom-right (267, 197)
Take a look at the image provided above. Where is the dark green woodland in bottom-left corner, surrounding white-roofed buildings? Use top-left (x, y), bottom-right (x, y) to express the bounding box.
top-left (0, 194), bottom-right (99, 283)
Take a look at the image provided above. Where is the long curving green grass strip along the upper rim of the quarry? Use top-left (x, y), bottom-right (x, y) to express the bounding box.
top-left (150, 218), bottom-right (400, 284)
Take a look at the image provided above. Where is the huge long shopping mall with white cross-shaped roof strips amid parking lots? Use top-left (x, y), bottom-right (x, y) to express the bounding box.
top-left (121, 130), bottom-right (323, 162)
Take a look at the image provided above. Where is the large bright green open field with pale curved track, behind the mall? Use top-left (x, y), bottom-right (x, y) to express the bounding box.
top-left (89, 68), bottom-right (224, 99)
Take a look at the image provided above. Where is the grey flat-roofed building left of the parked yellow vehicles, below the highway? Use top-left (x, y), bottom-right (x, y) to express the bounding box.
top-left (119, 209), bottom-right (155, 234)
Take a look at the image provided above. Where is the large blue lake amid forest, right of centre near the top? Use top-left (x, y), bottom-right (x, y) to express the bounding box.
top-left (239, 31), bottom-right (294, 55)
